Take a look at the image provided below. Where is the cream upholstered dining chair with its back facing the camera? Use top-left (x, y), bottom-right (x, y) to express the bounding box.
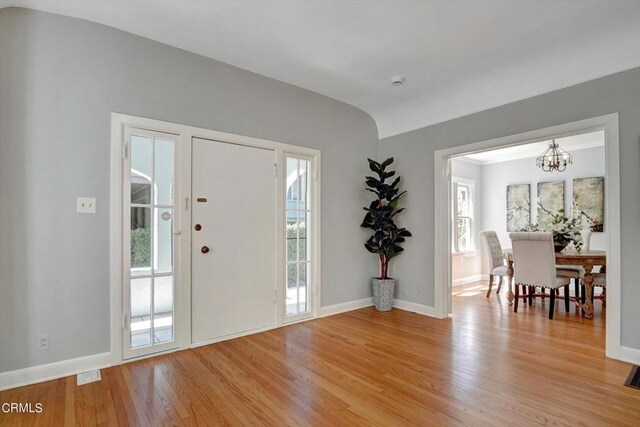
top-left (509, 232), bottom-right (571, 319)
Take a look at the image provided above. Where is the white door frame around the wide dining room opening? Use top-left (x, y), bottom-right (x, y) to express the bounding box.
top-left (434, 113), bottom-right (622, 359)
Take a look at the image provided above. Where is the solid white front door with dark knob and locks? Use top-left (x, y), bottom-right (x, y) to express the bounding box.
top-left (191, 138), bottom-right (277, 343)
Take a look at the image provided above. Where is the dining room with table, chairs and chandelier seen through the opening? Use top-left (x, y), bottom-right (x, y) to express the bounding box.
top-left (450, 130), bottom-right (607, 336)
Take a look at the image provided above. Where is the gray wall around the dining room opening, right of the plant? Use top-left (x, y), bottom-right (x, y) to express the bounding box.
top-left (379, 68), bottom-right (640, 349)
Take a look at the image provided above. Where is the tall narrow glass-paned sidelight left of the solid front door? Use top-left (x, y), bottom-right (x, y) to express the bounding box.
top-left (123, 128), bottom-right (180, 359)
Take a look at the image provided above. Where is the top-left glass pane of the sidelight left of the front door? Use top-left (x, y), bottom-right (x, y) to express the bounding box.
top-left (131, 135), bottom-right (153, 204)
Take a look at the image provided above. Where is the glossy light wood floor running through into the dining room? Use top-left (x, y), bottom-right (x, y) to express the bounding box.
top-left (0, 284), bottom-right (640, 426)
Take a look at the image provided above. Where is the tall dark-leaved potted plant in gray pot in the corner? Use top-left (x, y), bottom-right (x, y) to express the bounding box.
top-left (361, 157), bottom-right (411, 311)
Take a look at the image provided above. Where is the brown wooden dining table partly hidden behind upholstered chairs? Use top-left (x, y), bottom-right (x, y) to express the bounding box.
top-left (503, 248), bottom-right (607, 319)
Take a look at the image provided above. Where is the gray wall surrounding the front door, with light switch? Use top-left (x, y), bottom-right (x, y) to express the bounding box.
top-left (0, 8), bottom-right (378, 371)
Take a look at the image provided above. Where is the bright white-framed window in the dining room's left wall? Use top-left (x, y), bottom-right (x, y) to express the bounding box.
top-left (452, 178), bottom-right (475, 253)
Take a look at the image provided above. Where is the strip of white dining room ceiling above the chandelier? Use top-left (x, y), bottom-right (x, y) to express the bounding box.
top-left (457, 131), bottom-right (604, 165)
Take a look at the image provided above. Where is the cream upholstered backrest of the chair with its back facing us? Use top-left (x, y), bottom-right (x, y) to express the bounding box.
top-left (509, 232), bottom-right (556, 286)
